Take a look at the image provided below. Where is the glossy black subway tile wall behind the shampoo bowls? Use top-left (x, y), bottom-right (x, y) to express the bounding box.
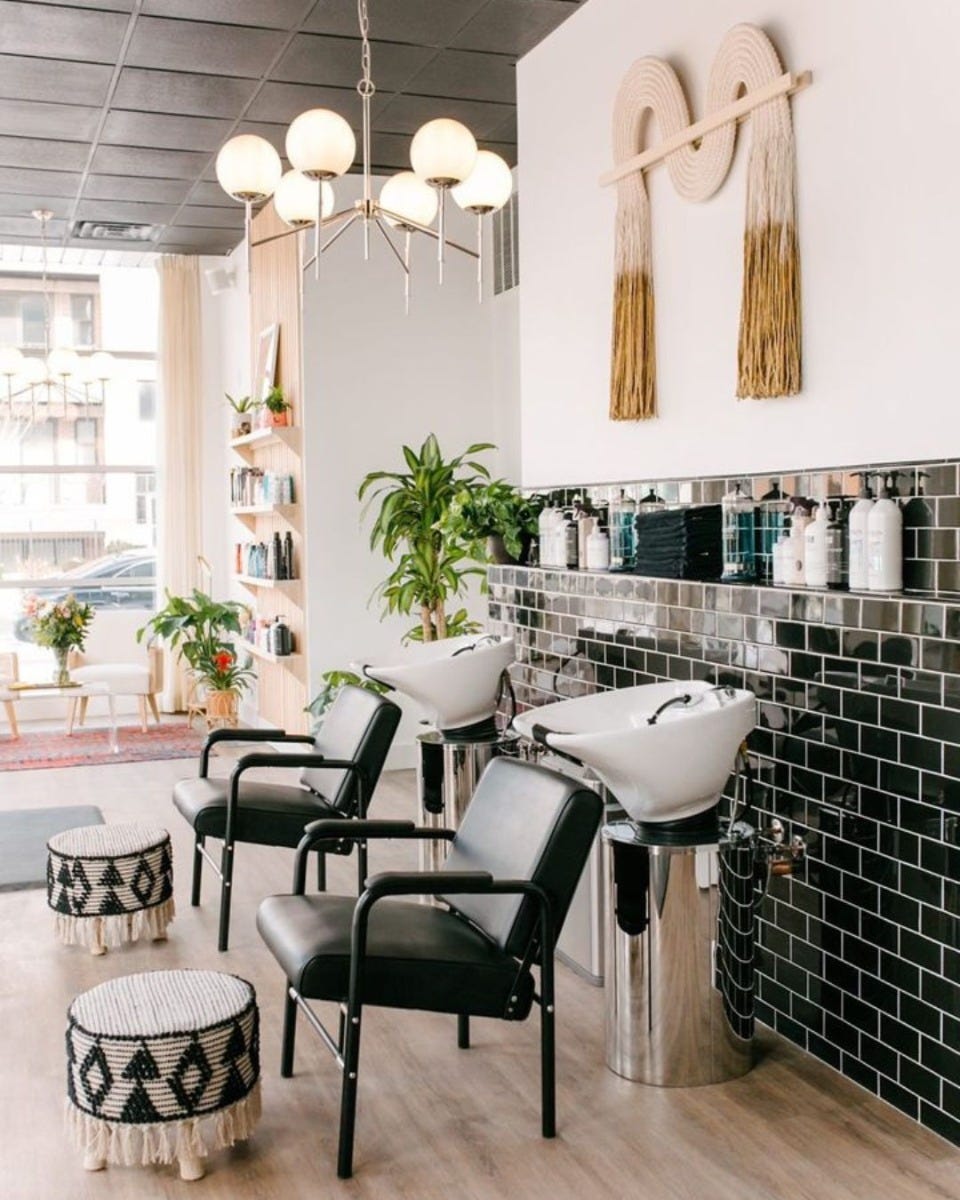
top-left (490, 453), bottom-right (960, 1142)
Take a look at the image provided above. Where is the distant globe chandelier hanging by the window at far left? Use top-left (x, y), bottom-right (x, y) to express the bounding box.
top-left (0, 209), bottom-right (116, 440)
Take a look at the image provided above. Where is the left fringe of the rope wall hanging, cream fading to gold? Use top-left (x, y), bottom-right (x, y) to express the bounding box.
top-left (610, 179), bottom-right (656, 421)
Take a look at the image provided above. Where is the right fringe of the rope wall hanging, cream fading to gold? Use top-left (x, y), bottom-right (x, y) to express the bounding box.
top-left (737, 133), bottom-right (800, 400)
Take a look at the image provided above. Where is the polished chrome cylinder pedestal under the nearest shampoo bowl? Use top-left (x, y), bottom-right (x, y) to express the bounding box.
top-left (602, 821), bottom-right (755, 1087)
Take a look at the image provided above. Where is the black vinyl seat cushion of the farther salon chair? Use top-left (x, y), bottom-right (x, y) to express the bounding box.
top-left (173, 779), bottom-right (343, 850)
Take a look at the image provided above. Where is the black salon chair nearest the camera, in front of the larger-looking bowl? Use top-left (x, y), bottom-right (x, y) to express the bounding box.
top-left (257, 758), bottom-right (601, 1178)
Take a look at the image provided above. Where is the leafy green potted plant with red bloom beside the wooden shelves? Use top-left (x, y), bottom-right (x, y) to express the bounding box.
top-left (137, 588), bottom-right (253, 691)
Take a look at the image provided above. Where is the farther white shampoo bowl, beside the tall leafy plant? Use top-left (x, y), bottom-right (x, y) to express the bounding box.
top-left (358, 634), bottom-right (516, 731)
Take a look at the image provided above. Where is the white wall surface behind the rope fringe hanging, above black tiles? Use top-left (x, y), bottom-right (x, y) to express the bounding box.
top-left (518, 0), bottom-right (960, 486)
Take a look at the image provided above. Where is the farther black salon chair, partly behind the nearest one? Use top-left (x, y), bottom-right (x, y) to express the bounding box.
top-left (173, 685), bottom-right (400, 950)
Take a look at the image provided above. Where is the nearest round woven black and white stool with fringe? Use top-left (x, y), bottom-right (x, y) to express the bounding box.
top-left (67, 971), bottom-right (260, 1180)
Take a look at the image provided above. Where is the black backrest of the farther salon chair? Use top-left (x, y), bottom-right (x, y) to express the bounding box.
top-left (300, 684), bottom-right (400, 816)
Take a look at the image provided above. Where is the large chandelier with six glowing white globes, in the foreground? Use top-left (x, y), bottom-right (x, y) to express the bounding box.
top-left (216, 0), bottom-right (514, 308)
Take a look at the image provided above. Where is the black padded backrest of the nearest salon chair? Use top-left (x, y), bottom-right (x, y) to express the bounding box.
top-left (443, 758), bottom-right (604, 958)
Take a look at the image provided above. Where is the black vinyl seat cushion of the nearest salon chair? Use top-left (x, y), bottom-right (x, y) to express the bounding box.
top-left (257, 895), bottom-right (534, 1020)
